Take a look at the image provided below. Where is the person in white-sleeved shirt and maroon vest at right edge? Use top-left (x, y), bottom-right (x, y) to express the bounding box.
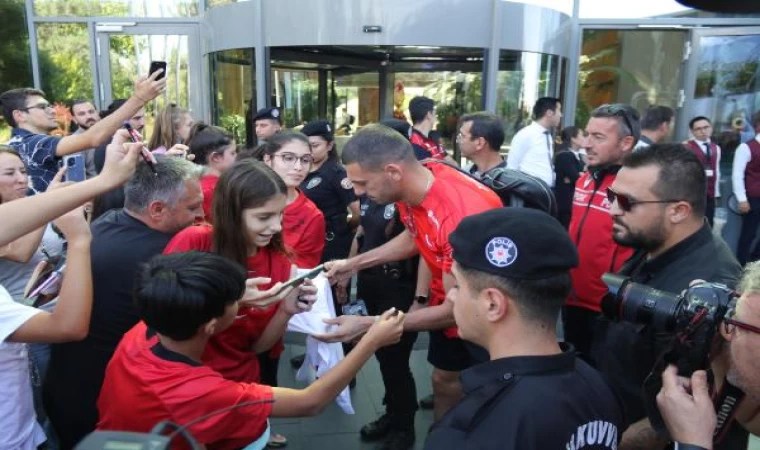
top-left (731, 111), bottom-right (760, 265)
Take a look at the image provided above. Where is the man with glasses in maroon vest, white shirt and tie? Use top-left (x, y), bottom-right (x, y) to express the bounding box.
top-left (684, 116), bottom-right (721, 226)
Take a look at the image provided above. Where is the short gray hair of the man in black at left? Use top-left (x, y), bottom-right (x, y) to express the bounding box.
top-left (124, 156), bottom-right (203, 213)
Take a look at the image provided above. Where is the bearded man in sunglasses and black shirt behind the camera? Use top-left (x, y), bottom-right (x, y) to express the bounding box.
top-left (591, 144), bottom-right (747, 450)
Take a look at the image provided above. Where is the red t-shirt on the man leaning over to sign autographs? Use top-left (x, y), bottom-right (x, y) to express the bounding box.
top-left (396, 162), bottom-right (503, 337)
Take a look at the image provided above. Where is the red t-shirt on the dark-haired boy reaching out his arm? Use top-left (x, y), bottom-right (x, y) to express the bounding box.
top-left (98, 322), bottom-right (274, 450)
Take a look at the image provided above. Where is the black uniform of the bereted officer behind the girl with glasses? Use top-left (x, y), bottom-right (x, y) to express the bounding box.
top-left (301, 158), bottom-right (356, 261)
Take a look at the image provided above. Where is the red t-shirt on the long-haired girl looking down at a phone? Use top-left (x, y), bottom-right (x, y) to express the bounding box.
top-left (164, 224), bottom-right (290, 383)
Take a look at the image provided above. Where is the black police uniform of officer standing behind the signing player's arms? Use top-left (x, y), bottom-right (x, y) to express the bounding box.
top-left (357, 196), bottom-right (419, 432)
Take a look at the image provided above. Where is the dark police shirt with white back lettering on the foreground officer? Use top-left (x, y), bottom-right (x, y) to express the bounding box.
top-left (425, 346), bottom-right (625, 450)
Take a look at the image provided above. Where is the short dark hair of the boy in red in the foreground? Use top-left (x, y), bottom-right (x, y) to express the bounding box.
top-left (134, 251), bottom-right (246, 341)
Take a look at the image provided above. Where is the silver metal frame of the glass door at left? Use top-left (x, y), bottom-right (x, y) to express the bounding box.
top-left (93, 21), bottom-right (203, 119)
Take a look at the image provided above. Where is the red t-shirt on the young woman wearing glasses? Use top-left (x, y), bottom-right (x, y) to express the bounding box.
top-left (282, 190), bottom-right (325, 269)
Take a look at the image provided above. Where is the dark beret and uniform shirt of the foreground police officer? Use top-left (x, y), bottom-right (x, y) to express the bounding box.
top-left (425, 208), bottom-right (625, 450)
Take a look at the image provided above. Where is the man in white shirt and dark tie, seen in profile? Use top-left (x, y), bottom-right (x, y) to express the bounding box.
top-left (507, 97), bottom-right (562, 187)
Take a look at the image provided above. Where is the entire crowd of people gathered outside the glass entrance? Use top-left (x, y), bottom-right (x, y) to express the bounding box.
top-left (0, 68), bottom-right (760, 450)
